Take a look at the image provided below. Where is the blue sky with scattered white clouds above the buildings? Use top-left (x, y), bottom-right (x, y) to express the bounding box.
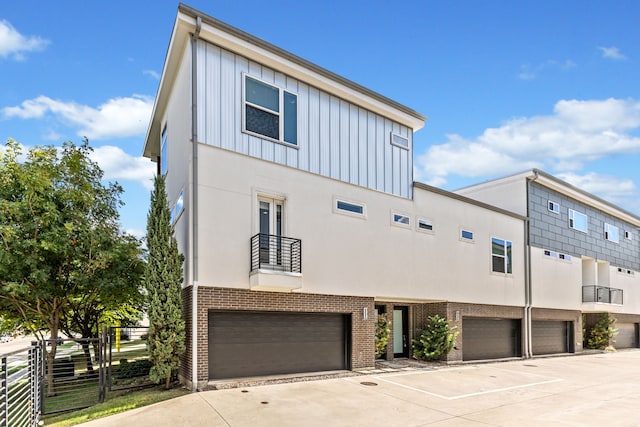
top-left (0, 0), bottom-right (640, 236)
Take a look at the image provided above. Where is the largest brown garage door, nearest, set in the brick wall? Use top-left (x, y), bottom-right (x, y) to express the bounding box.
top-left (209, 311), bottom-right (350, 379)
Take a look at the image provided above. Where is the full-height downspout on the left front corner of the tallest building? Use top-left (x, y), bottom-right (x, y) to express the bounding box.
top-left (191, 16), bottom-right (202, 391)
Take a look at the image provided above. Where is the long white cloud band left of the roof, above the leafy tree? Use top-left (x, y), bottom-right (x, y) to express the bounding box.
top-left (0, 95), bottom-right (153, 140)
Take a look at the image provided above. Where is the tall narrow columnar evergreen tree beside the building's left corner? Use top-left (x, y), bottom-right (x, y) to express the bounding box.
top-left (144, 176), bottom-right (185, 389)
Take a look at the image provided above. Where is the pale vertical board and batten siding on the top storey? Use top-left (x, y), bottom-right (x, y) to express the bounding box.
top-left (197, 41), bottom-right (413, 198)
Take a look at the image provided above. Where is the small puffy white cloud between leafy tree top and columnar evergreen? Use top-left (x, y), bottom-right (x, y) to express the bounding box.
top-left (90, 145), bottom-right (156, 190)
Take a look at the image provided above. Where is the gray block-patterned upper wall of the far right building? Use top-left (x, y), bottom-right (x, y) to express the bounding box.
top-left (529, 182), bottom-right (640, 271)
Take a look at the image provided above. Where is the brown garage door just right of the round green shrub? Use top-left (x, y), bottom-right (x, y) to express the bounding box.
top-left (462, 317), bottom-right (521, 360)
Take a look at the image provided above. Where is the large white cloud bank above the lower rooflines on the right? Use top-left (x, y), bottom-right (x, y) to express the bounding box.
top-left (416, 99), bottom-right (640, 185)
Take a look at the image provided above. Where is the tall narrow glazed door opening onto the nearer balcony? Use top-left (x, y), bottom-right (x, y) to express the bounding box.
top-left (258, 197), bottom-right (283, 268)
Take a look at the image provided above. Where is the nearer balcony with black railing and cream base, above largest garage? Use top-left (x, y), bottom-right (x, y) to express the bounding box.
top-left (249, 233), bottom-right (302, 292)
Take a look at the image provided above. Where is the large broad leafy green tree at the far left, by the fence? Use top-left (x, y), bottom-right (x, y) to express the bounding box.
top-left (0, 139), bottom-right (141, 395)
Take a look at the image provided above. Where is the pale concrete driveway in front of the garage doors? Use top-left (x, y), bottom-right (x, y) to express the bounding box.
top-left (84, 350), bottom-right (640, 427)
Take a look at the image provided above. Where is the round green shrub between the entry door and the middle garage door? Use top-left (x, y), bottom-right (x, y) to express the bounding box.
top-left (412, 314), bottom-right (458, 360)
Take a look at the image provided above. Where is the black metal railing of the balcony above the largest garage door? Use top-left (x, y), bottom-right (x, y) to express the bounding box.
top-left (251, 233), bottom-right (302, 273)
